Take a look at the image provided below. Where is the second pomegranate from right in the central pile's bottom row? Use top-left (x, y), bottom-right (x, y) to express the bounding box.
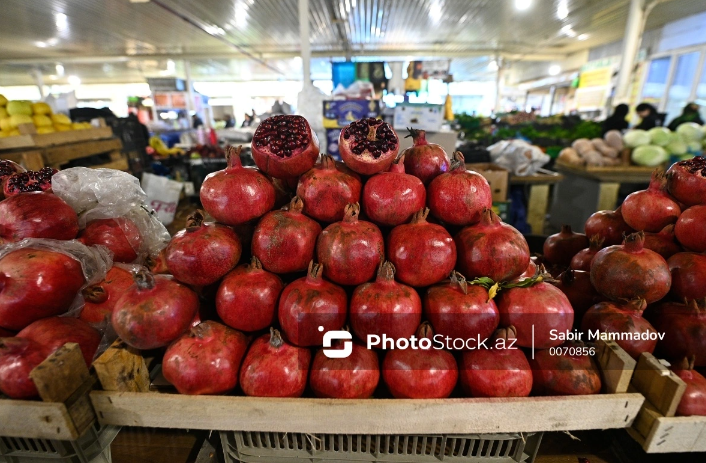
top-left (459, 326), bottom-right (532, 397)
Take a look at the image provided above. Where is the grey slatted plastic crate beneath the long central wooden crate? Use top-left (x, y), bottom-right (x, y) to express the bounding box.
top-left (220, 431), bottom-right (542, 463)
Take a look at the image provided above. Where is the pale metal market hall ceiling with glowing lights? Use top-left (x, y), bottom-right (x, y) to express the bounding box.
top-left (0, 0), bottom-right (706, 85)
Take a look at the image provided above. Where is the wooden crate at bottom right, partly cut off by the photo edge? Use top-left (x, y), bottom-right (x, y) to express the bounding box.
top-left (628, 353), bottom-right (706, 453)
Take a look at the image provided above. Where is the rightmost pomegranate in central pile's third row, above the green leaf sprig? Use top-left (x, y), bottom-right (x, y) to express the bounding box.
top-left (452, 209), bottom-right (530, 282)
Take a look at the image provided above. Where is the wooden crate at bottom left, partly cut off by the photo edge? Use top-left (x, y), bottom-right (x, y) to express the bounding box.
top-left (0, 343), bottom-right (95, 440)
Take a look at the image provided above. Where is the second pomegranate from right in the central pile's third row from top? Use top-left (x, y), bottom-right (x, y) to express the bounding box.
top-left (385, 208), bottom-right (456, 288)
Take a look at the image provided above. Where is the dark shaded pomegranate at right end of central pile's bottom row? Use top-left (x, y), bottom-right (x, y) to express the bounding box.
top-left (529, 341), bottom-right (601, 395)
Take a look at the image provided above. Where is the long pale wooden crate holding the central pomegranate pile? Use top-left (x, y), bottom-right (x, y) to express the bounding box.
top-left (91, 343), bottom-right (644, 434)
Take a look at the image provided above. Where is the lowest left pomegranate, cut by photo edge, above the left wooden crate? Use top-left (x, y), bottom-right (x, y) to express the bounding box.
top-left (0, 337), bottom-right (50, 400)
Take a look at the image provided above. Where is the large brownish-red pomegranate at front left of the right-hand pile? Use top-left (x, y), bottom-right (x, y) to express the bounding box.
top-left (591, 232), bottom-right (672, 304)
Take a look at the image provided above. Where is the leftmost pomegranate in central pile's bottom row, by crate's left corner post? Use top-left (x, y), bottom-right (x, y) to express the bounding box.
top-left (162, 321), bottom-right (248, 395)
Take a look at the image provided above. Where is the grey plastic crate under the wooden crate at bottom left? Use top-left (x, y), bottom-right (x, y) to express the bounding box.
top-left (0, 422), bottom-right (120, 463)
